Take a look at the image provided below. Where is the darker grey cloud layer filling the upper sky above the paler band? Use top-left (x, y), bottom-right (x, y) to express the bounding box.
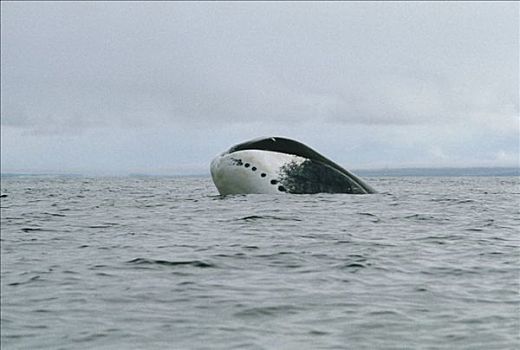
top-left (2, 3), bottom-right (518, 127)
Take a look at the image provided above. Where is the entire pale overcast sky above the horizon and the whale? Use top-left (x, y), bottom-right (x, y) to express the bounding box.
top-left (1, 1), bottom-right (520, 174)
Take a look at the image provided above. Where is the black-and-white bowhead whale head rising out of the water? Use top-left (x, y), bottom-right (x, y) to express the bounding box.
top-left (210, 137), bottom-right (376, 195)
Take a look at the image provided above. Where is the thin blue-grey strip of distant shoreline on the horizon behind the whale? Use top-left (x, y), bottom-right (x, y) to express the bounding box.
top-left (0, 167), bottom-right (520, 178)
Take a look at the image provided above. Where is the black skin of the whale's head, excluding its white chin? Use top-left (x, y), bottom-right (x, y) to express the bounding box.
top-left (227, 137), bottom-right (376, 194)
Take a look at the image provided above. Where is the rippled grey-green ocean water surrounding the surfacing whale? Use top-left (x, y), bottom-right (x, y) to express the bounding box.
top-left (1, 176), bottom-right (520, 349)
